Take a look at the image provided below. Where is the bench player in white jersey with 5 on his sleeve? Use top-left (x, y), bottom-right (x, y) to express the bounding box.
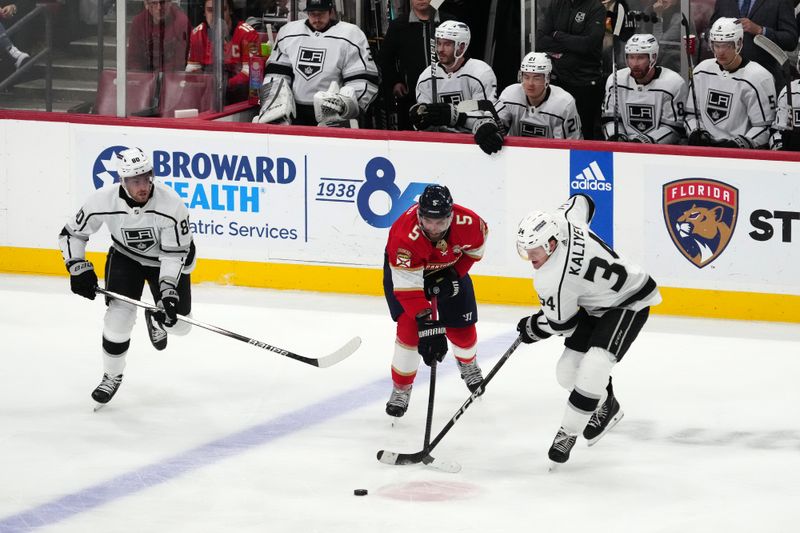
top-left (686, 18), bottom-right (775, 148)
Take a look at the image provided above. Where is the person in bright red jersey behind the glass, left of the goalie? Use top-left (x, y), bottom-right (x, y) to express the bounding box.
top-left (186, 0), bottom-right (261, 104)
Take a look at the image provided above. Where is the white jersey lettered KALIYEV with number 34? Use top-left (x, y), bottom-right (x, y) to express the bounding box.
top-left (533, 194), bottom-right (661, 336)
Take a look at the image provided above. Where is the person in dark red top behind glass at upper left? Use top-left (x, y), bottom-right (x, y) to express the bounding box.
top-left (128, 0), bottom-right (192, 72)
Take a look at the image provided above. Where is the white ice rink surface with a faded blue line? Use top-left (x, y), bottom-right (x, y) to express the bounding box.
top-left (0, 276), bottom-right (800, 533)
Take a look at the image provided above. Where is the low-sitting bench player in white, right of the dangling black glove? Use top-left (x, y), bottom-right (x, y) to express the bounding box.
top-left (497, 52), bottom-right (583, 139)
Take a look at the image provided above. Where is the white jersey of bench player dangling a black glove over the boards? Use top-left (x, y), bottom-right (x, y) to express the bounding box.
top-left (416, 58), bottom-right (497, 131)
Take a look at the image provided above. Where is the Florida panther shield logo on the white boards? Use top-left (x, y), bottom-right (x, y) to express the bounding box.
top-left (663, 178), bottom-right (739, 268)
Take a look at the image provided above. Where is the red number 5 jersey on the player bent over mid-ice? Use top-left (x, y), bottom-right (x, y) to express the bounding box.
top-left (386, 204), bottom-right (489, 317)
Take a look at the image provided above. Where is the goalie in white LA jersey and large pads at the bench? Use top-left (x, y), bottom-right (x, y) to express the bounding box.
top-left (253, 0), bottom-right (380, 126)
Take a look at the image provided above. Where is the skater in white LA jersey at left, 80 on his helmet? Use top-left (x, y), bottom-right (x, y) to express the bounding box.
top-left (58, 148), bottom-right (195, 404)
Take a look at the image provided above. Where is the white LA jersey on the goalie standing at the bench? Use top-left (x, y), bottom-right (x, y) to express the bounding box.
top-left (264, 20), bottom-right (380, 111)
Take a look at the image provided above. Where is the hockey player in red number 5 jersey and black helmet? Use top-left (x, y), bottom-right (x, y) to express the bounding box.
top-left (383, 185), bottom-right (488, 417)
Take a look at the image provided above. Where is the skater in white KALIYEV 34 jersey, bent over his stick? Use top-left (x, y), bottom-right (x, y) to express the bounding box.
top-left (517, 194), bottom-right (661, 463)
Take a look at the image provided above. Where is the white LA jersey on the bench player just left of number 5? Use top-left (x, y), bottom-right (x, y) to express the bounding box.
top-left (603, 67), bottom-right (687, 144)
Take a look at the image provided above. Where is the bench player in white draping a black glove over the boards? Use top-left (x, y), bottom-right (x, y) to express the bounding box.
top-left (409, 20), bottom-right (503, 154)
